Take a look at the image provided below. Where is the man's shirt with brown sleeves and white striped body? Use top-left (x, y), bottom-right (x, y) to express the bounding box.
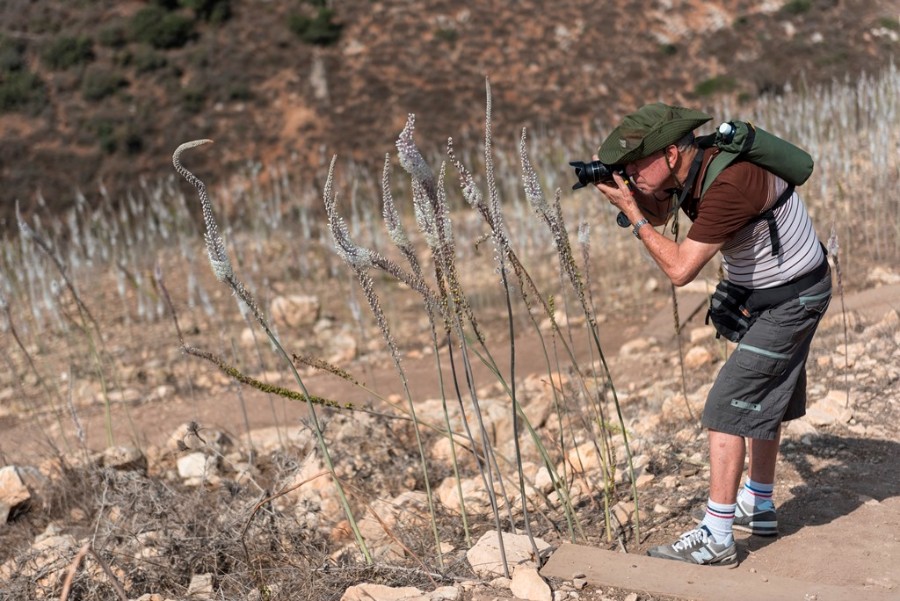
top-left (684, 150), bottom-right (824, 288)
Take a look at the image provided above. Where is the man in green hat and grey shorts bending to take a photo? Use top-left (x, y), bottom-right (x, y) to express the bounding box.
top-left (595, 103), bottom-right (831, 566)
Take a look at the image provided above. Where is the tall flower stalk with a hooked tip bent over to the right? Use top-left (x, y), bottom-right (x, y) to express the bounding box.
top-left (172, 140), bottom-right (372, 564)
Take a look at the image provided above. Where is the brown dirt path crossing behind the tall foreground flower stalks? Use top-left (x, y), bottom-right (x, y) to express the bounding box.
top-left (0, 310), bottom-right (642, 463)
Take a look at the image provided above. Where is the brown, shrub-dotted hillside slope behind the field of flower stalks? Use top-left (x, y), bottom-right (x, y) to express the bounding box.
top-left (0, 0), bottom-right (900, 225)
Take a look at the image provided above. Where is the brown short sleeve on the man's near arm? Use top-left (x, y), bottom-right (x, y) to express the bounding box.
top-left (687, 161), bottom-right (772, 244)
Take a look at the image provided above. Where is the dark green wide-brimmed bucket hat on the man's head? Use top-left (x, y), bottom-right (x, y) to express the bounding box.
top-left (597, 102), bottom-right (712, 165)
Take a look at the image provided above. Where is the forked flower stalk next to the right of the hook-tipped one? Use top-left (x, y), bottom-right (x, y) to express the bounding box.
top-left (323, 157), bottom-right (444, 566)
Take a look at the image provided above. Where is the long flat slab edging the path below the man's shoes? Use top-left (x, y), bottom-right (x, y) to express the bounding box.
top-left (541, 544), bottom-right (897, 601)
